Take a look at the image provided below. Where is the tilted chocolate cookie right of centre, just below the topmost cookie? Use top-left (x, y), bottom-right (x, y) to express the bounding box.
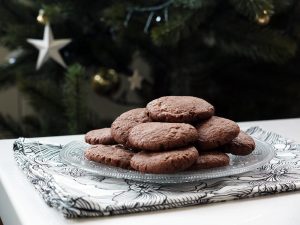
top-left (195, 116), bottom-right (240, 151)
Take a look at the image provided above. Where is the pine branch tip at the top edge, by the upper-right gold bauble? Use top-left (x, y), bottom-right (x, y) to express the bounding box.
top-left (229, 0), bottom-right (274, 20)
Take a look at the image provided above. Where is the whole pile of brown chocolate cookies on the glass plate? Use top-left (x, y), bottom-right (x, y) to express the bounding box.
top-left (85, 96), bottom-right (255, 173)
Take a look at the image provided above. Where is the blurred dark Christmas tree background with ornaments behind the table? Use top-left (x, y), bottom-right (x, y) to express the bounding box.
top-left (0, 0), bottom-right (300, 138)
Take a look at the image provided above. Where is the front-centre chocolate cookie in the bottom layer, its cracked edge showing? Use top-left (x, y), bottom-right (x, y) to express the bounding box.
top-left (130, 147), bottom-right (198, 173)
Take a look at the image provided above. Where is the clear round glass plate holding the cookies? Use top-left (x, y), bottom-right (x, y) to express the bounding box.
top-left (60, 138), bottom-right (274, 183)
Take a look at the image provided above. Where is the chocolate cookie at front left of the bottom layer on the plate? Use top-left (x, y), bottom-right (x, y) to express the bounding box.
top-left (84, 145), bottom-right (134, 169)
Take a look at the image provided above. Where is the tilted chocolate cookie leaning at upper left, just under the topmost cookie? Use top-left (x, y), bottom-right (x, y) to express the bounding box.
top-left (111, 108), bottom-right (151, 146)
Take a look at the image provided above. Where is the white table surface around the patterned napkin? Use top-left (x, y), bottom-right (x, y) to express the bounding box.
top-left (0, 119), bottom-right (300, 225)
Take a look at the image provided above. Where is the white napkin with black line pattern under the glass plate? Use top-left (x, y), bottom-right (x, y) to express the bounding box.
top-left (14, 127), bottom-right (300, 218)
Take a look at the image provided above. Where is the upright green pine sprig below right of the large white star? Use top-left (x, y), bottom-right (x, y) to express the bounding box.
top-left (63, 64), bottom-right (87, 134)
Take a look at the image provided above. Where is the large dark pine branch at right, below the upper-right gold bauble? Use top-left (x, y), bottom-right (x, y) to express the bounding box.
top-left (211, 14), bottom-right (297, 63)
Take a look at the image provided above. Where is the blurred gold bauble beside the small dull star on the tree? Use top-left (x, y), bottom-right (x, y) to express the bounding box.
top-left (92, 68), bottom-right (120, 95)
